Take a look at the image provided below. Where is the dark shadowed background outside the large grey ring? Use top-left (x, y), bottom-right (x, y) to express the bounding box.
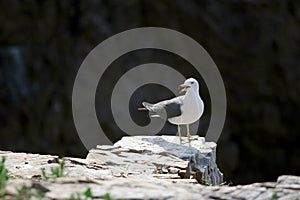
top-left (0, 0), bottom-right (300, 184)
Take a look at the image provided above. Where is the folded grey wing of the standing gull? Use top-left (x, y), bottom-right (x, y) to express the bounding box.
top-left (143, 96), bottom-right (184, 120)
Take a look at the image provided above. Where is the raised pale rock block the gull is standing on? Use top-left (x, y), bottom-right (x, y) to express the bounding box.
top-left (87, 136), bottom-right (223, 185)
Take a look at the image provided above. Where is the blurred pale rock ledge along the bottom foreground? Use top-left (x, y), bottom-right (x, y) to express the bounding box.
top-left (3, 176), bottom-right (300, 200)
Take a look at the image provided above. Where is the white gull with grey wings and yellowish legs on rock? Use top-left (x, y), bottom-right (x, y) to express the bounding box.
top-left (139, 78), bottom-right (204, 143)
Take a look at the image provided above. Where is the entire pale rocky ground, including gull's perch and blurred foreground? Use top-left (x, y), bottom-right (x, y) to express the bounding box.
top-left (0, 136), bottom-right (300, 200)
